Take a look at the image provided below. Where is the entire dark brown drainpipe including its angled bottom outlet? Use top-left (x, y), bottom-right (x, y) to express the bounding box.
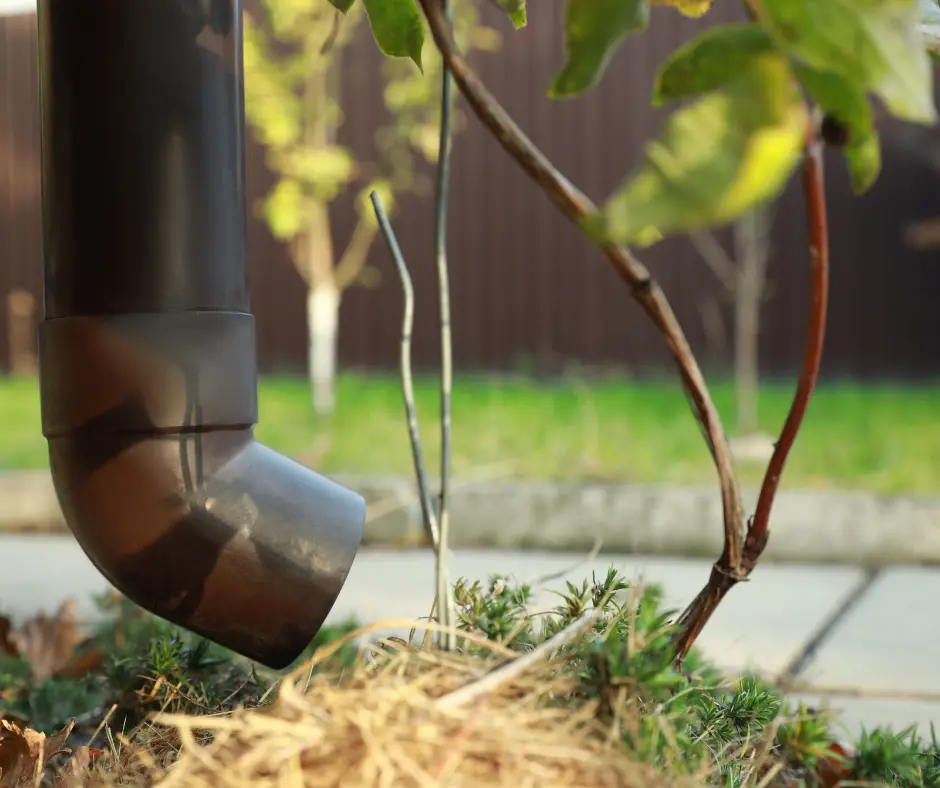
top-left (39, 0), bottom-right (365, 667)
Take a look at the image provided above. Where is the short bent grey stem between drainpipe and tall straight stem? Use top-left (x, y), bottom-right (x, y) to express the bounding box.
top-left (369, 192), bottom-right (441, 553)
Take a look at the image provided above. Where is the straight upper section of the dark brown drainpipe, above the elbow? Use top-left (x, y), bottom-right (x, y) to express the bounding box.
top-left (38, 0), bottom-right (249, 318)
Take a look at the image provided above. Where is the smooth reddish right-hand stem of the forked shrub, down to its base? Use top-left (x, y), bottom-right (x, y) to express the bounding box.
top-left (676, 130), bottom-right (829, 662)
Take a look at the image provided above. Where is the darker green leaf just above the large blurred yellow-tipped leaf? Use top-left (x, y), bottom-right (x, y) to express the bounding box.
top-left (653, 25), bottom-right (774, 107)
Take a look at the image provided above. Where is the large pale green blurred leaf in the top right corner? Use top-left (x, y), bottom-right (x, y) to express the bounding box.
top-left (755, 0), bottom-right (937, 124)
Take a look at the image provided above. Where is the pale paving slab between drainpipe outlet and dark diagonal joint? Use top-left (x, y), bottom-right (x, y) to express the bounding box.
top-left (334, 550), bottom-right (863, 673)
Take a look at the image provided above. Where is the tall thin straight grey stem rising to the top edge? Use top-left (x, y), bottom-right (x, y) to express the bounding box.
top-left (434, 0), bottom-right (457, 651)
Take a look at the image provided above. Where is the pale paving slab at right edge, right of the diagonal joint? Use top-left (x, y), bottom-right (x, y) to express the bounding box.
top-left (800, 567), bottom-right (940, 692)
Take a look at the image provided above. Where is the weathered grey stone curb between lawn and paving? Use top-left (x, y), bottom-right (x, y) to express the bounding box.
top-left (0, 470), bottom-right (940, 566)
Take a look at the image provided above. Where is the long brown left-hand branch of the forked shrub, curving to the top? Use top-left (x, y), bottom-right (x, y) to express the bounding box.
top-left (420, 0), bottom-right (744, 566)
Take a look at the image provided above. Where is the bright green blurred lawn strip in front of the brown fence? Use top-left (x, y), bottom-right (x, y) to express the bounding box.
top-left (0, 374), bottom-right (940, 493)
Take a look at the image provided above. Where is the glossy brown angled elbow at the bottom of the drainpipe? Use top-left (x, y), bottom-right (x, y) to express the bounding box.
top-left (40, 312), bottom-right (365, 668)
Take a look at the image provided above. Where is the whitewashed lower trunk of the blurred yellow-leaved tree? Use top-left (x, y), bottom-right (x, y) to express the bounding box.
top-left (307, 281), bottom-right (340, 416)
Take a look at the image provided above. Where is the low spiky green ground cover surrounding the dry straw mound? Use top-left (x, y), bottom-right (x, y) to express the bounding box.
top-left (0, 569), bottom-right (940, 788)
